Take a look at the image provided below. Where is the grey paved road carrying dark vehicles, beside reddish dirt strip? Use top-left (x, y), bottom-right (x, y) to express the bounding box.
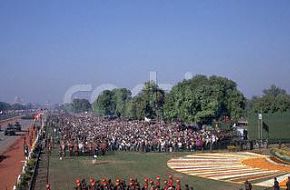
top-left (0, 119), bottom-right (33, 155)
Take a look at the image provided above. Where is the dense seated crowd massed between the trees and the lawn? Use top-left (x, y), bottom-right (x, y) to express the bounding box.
top-left (50, 115), bottom-right (230, 157)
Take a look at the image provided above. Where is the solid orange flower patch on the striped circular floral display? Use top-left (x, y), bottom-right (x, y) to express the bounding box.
top-left (242, 158), bottom-right (290, 172)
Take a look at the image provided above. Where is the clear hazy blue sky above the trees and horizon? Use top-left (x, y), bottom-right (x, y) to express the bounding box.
top-left (0, 0), bottom-right (290, 103)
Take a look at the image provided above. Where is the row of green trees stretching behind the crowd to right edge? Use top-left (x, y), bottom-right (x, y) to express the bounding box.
top-left (62, 75), bottom-right (290, 124)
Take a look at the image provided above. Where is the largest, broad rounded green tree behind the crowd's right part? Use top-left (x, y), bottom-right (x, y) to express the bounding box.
top-left (164, 75), bottom-right (245, 124)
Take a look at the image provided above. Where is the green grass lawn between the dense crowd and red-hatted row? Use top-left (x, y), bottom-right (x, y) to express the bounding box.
top-left (44, 152), bottom-right (270, 190)
